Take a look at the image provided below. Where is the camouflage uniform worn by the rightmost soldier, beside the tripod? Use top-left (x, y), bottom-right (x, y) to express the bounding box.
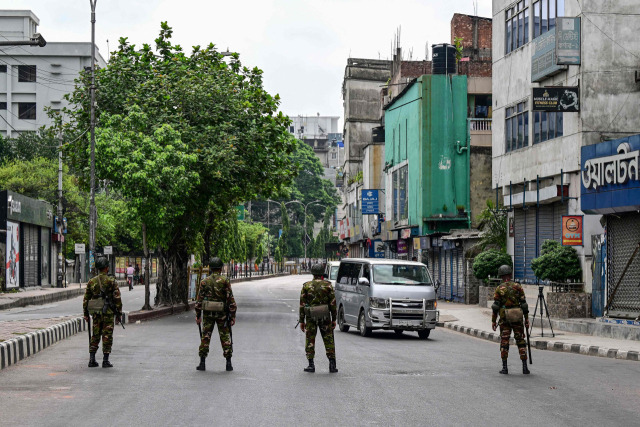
top-left (491, 282), bottom-right (529, 360)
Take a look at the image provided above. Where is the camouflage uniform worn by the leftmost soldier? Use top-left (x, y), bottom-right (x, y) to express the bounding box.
top-left (82, 272), bottom-right (122, 354)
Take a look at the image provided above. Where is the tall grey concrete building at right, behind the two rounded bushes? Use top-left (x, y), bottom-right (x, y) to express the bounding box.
top-left (492, 0), bottom-right (640, 290)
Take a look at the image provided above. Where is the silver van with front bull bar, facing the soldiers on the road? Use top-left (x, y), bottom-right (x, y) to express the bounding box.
top-left (335, 258), bottom-right (439, 339)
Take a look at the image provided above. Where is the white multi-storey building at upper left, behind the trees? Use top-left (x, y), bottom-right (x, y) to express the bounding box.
top-left (0, 10), bottom-right (106, 137)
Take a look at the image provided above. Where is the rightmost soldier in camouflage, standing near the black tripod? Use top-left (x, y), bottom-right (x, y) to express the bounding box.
top-left (491, 265), bottom-right (529, 374)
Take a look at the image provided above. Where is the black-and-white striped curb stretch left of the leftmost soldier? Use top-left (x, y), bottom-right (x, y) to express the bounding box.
top-left (0, 317), bottom-right (87, 369)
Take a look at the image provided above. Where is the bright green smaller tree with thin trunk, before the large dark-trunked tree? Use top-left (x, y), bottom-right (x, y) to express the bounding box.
top-left (96, 105), bottom-right (199, 310)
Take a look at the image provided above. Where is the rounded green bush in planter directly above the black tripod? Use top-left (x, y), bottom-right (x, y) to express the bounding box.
top-left (531, 240), bottom-right (582, 282)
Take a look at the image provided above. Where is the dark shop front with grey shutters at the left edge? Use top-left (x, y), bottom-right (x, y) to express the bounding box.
top-left (0, 190), bottom-right (55, 290)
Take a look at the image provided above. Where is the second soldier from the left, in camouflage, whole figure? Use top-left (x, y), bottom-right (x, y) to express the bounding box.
top-left (196, 257), bottom-right (238, 371)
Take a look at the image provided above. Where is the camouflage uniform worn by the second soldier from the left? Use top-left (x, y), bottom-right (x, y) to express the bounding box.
top-left (196, 275), bottom-right (238, 359)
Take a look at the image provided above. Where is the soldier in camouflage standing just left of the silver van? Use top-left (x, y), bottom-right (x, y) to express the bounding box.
top-left (299, 264), bottom-right (338, 373)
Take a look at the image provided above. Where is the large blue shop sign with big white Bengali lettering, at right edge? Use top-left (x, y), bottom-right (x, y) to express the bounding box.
top-left (580, 135), bottom-right (640, 214)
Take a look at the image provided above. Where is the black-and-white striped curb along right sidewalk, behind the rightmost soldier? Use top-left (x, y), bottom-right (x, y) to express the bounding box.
top-left (444, 322), bottom-right (640, 361)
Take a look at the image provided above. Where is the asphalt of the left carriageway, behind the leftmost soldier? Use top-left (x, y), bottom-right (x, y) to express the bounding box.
top-left (0, 284), bottom-right (156, 321)
